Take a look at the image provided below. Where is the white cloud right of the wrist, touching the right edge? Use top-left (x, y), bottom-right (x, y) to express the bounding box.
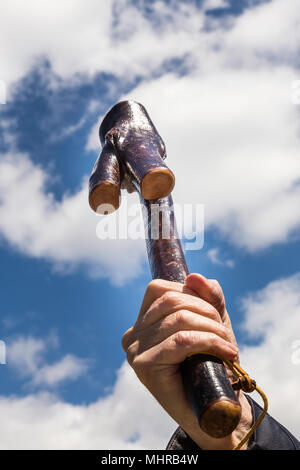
top-left (241, 273), bottom-right (300, 439)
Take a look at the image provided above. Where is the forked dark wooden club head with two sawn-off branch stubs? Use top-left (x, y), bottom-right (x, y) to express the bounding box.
top-left (89, 101), bottom-right (175, 214)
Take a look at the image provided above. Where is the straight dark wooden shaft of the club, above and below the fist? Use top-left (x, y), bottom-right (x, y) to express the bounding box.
top-left (140, 196), bottom-right (241, 438)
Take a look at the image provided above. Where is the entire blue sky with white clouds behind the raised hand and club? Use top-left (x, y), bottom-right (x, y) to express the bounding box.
top-left (0, 0), bottom-right (300, 449)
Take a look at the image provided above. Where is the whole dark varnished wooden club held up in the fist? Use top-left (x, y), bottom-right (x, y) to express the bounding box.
top-left (89, 101), bottom-right (241, 438)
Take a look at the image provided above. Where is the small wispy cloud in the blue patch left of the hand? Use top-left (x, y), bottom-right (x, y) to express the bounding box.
top-left (8, 334), bottom-right (89, 388)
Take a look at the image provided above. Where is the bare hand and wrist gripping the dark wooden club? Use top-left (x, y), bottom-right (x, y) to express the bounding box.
top-left (122, 274), bottom-right (252, 449)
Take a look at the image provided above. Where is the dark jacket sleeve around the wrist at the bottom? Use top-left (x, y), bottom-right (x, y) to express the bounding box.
top-left (167, 395), bottom-right (300, 452)
